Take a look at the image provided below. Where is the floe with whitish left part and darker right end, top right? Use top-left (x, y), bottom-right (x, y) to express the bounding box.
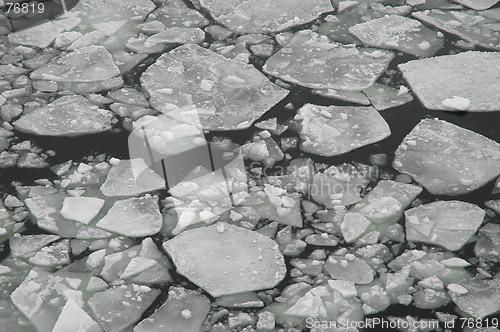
top-left (349, 15), bottom-right (444, 57)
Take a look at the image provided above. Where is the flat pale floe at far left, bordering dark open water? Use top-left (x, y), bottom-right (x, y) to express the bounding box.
top-left (13, 95), bottom-right (113, 136)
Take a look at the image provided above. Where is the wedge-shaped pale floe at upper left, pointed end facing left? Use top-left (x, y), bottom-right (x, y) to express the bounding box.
top-left (30, 46), bottom-right (120, 83)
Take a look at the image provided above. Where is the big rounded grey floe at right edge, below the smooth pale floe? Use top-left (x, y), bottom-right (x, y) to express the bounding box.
top-left (393, 119), bottom-right (500, 196)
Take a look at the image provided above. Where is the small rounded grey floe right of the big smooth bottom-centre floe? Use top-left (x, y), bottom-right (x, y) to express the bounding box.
top-left (325, 255), bottom-right (375, 284)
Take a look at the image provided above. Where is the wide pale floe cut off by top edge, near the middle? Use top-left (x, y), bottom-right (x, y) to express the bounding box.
top-left (200, 0), bottom-right (333, 33)
